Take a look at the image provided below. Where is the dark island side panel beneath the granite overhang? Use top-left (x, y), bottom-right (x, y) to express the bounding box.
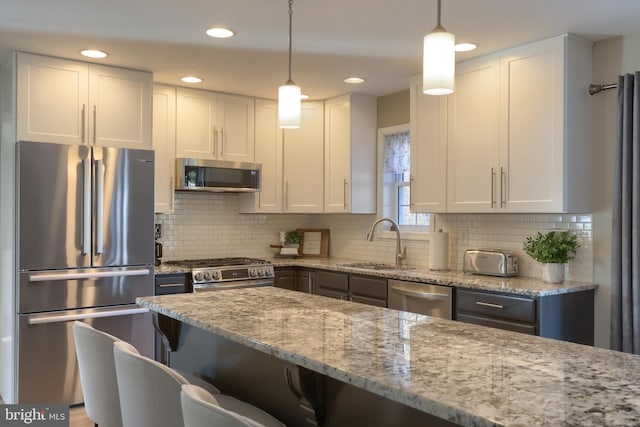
top-left (169, 323), bottom-right (456, 427)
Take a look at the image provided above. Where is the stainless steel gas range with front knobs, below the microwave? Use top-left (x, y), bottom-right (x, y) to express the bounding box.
top-left (166, 258), bottom-right (274, 292)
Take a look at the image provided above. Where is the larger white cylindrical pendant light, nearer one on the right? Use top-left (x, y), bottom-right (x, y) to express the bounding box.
top-left (422, 0), bottom-right (456, 95)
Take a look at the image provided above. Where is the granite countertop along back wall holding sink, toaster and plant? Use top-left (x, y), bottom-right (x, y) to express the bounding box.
top-left (271, 258), bottom-right (598, 298)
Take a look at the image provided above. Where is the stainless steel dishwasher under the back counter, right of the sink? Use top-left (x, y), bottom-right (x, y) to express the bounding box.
top-left (387, 279), bottom-right (453, 319)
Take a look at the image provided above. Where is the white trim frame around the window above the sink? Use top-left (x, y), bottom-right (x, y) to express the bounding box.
top-left (376, 123), bottom-right (435, 240)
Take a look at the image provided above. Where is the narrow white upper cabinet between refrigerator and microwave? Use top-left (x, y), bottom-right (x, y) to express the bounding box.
top-left (153, 85), bottom-right (176, 213)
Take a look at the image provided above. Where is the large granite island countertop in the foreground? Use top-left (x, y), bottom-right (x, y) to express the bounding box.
top-left (137, 287), bottom-right (640, 427)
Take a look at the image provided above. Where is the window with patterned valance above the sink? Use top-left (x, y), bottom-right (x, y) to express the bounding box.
top-left (379, 126), bottom-right (431, 232)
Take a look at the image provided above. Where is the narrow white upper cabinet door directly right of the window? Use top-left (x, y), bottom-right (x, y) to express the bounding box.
top-left (410, 75), bottom-right (447, 213)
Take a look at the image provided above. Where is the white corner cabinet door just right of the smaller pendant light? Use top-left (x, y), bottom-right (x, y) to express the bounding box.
top-left (283, 102), bottom-right (324, 213)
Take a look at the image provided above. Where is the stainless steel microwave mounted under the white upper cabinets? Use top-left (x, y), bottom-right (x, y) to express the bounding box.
top-left (176, 158), bottom-right (261, 193)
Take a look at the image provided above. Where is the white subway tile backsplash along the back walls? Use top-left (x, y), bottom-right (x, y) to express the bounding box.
top-left (156, 192), bottom-right (593, 281)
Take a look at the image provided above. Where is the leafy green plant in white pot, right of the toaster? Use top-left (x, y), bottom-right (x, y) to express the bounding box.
top-left (522, 231), bottom-right (579, 283)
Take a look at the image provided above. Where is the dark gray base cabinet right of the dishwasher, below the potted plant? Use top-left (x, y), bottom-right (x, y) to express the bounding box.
top-left (456, 288), bottom-right (594, 345)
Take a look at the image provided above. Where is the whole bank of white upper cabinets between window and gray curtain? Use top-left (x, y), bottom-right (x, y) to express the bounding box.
top-left (422, 35), bottom-right (591, 213)
